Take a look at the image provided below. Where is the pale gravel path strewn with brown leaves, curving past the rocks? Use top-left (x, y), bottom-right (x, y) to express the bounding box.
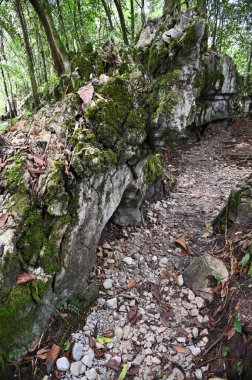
top-left (60, 119), bottom-right (251, 380)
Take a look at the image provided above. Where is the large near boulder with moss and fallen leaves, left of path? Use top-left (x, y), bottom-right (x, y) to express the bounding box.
top-left (0, 76), bottom-right (150, 351)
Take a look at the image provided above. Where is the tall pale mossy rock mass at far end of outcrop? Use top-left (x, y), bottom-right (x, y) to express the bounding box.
top-left (138, 13), bottom-right (242, 144)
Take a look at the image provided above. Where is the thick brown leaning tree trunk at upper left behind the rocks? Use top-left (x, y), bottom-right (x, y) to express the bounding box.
top-left (29, 0), bottom-right (71, 76)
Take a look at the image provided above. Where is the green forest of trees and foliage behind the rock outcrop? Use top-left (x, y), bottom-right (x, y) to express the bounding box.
top-left (0, 0), bottom-right (252, 114)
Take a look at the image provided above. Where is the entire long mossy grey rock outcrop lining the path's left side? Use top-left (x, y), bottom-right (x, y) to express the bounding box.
top-left (0, 9), bottom-right (245, 350)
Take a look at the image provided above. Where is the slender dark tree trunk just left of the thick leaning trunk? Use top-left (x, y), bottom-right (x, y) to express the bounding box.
top-left (15, 0), bottom-right (39, 107)
